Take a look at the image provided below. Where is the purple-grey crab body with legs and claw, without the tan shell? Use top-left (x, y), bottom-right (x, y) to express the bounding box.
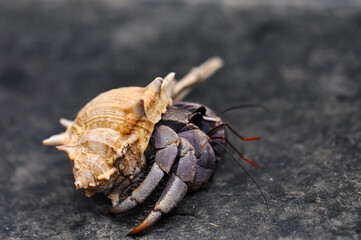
top-left (110, 102), bottom-right (225, 235)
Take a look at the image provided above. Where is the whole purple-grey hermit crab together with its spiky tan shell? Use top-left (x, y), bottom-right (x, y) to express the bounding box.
top-left (43, 57), bottom-right (258, 235)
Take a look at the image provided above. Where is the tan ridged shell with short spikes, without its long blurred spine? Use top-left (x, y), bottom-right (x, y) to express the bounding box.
top-left (44, 73), bottom-right (174, 195)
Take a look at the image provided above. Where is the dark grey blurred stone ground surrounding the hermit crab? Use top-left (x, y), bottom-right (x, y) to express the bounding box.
top-left (0, 0), bottom-right (361, 239)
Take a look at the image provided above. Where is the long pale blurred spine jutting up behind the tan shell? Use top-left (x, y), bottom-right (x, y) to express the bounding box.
top-left (172, 57), bottom-right (223, 102)
